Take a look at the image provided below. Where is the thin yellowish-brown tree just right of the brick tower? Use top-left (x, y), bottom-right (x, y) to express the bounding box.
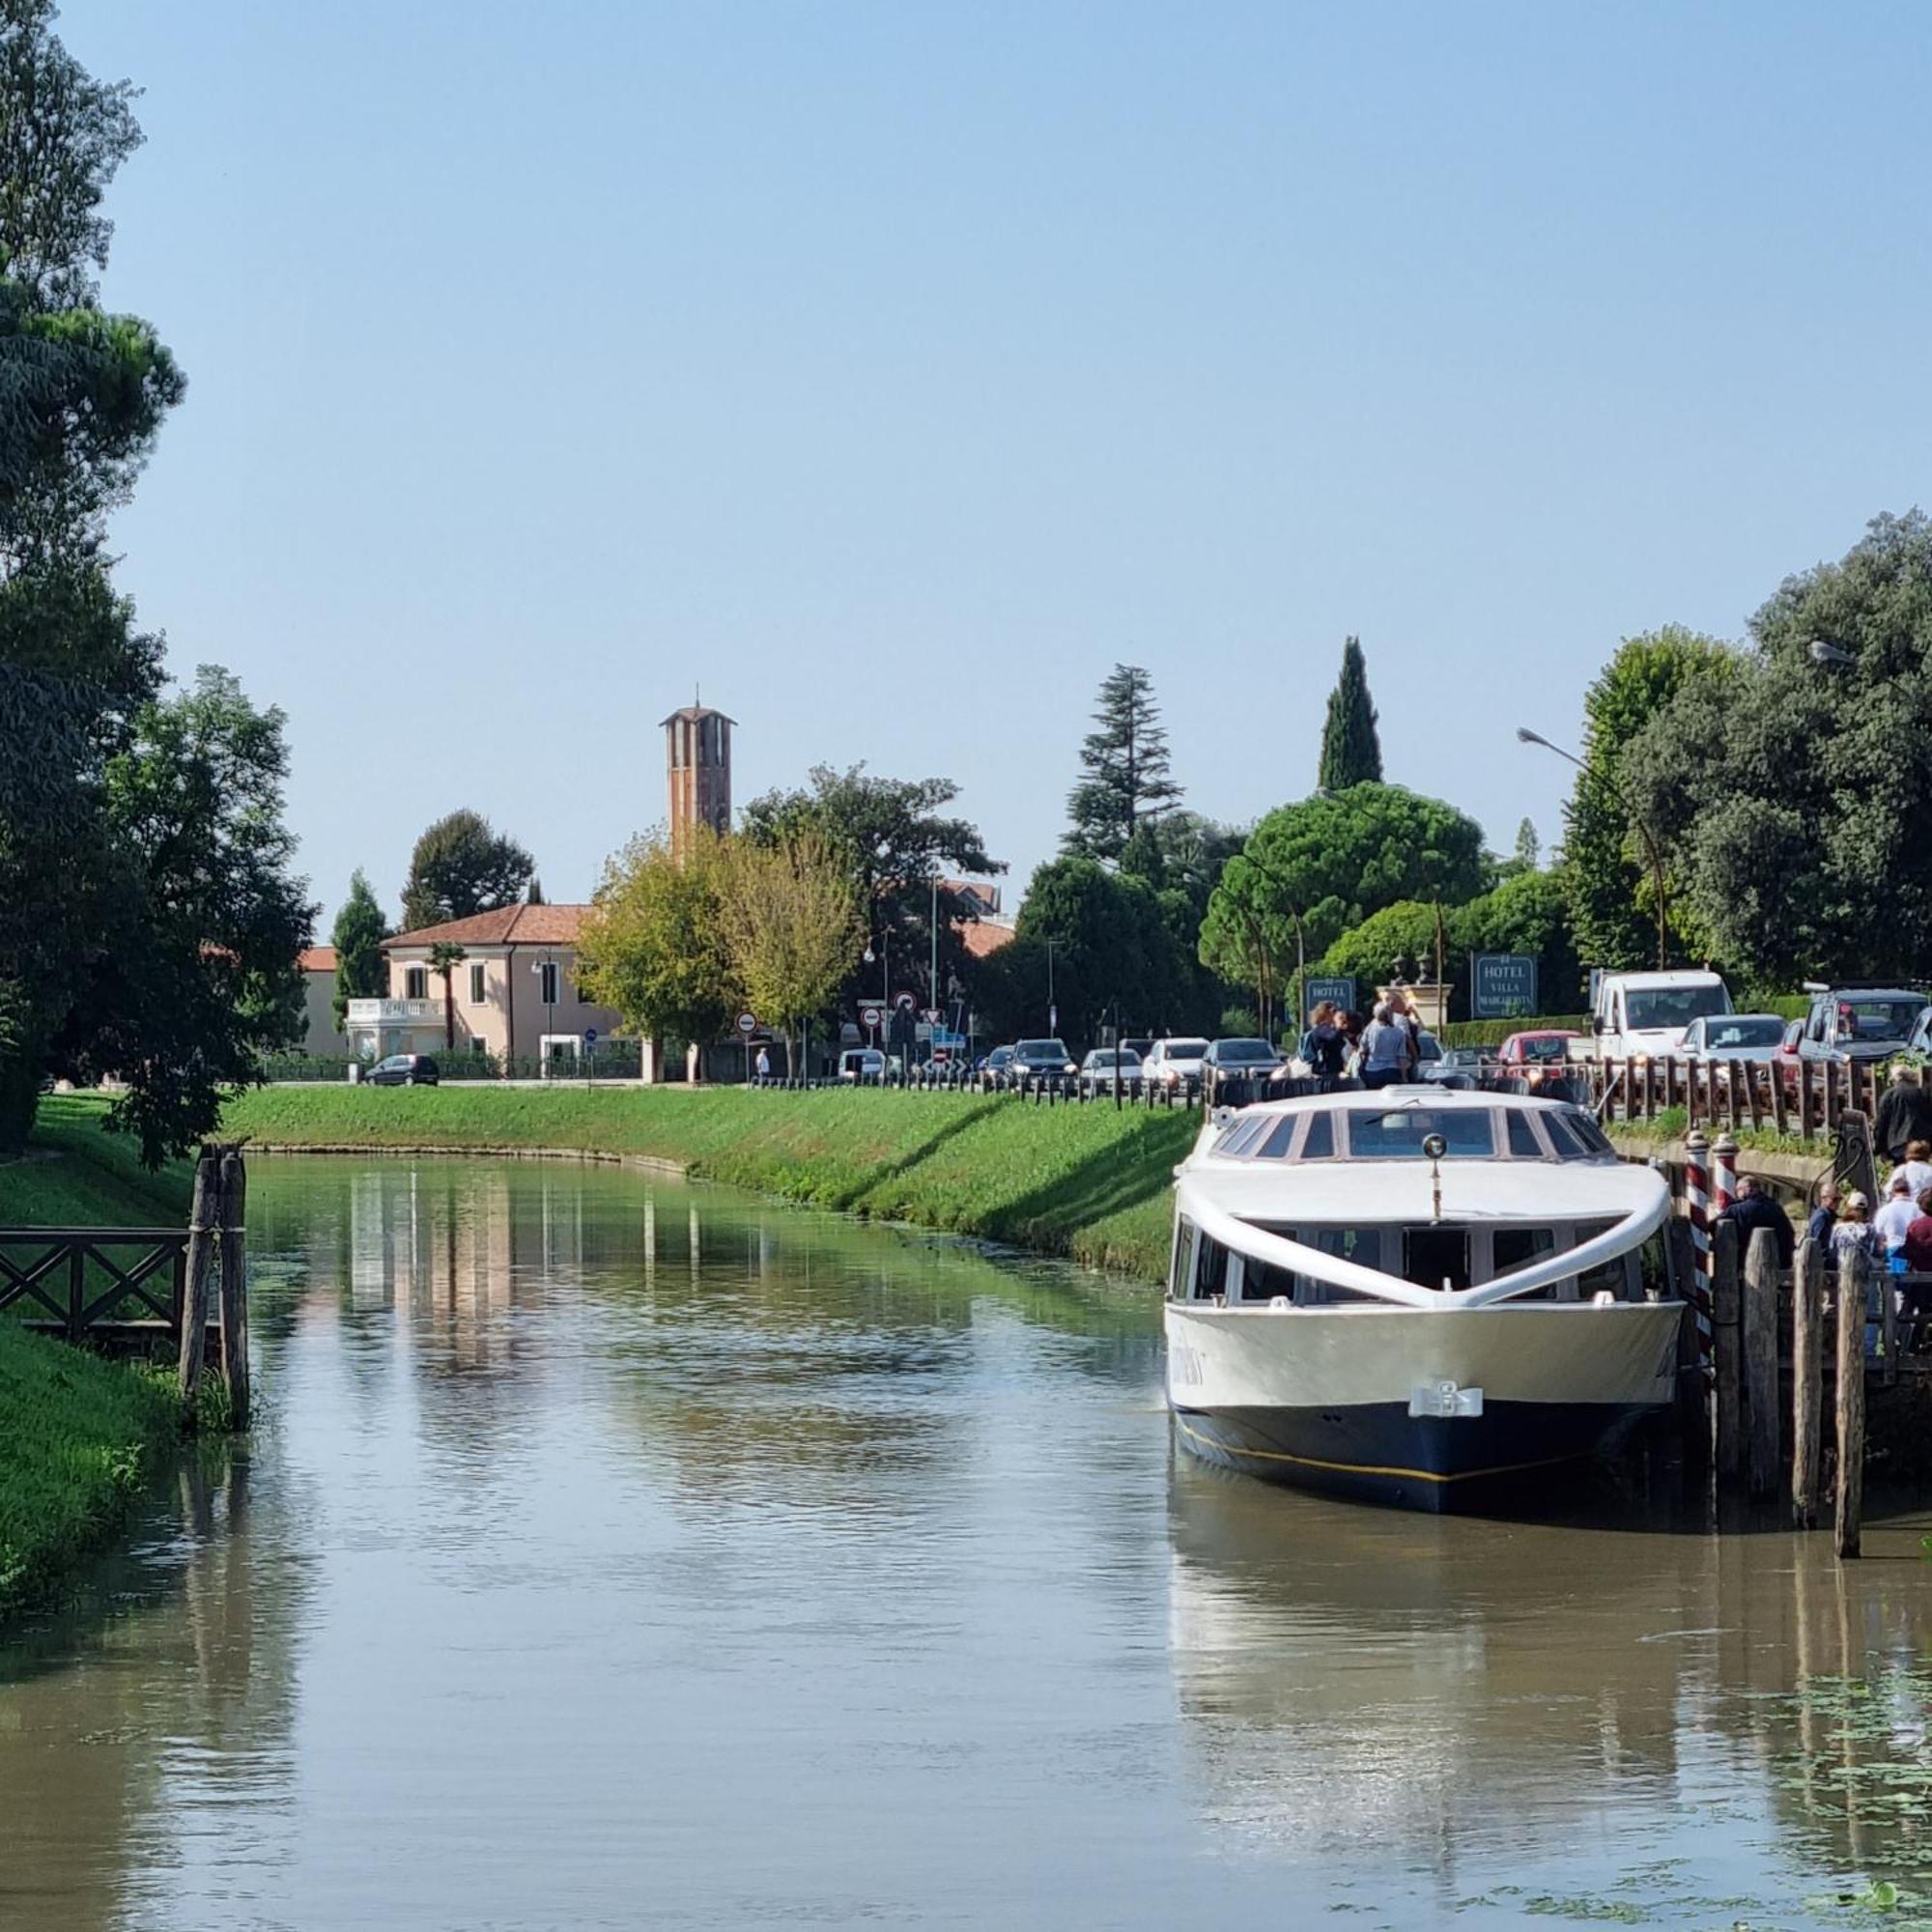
top-left (719, 831), bottom-right (866, 1068)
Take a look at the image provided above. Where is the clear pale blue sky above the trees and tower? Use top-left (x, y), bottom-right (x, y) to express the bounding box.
top-left (62, 0), bottom-right (1932, 927)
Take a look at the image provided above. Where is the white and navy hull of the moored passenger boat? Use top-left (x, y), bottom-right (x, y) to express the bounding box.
top-left (1167, 1302), bottom-right (1683, 1511)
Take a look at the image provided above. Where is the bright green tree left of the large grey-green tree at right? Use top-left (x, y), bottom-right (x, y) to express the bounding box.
top-left (1563, 624), bottom-right (1731, 970)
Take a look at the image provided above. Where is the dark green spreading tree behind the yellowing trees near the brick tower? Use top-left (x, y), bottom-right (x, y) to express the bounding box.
top-left (740, 765), bottom-right (1007, 1007)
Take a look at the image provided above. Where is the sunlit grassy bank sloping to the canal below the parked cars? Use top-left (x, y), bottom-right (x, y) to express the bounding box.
top-left (222, 1086), bottom-right (1200, 1281)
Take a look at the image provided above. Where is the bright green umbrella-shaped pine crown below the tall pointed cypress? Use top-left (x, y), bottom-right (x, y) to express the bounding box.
top-left (1200, 784), bottom-right (1490, 1016)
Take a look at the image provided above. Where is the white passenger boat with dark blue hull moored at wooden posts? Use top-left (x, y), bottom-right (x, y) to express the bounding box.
top-left (1167, 1086), bottom-right (1683, 1511)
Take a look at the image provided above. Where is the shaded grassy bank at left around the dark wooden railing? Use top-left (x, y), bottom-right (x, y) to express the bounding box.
top-left (0, 1099), bottom-right (187, 1619)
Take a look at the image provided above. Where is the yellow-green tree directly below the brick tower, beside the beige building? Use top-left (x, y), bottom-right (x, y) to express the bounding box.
top-left (578, 827), bottom-right (742, 1041)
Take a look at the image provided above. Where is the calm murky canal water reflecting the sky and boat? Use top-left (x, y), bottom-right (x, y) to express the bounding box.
top-left (0, 1161), bottom-right (1932, 1928)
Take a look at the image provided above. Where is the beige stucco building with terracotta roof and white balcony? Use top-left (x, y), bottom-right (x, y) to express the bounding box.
top-left (348, 906), bottom-right (618, 1061)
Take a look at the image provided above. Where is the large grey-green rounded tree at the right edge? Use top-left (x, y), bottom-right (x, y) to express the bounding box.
top-left (1621, 510), bottom-right (1932, 987)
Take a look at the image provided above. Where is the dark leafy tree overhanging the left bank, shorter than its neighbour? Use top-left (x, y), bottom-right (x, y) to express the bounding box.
top-left (52, 665), bottom-right (315, 1165)
